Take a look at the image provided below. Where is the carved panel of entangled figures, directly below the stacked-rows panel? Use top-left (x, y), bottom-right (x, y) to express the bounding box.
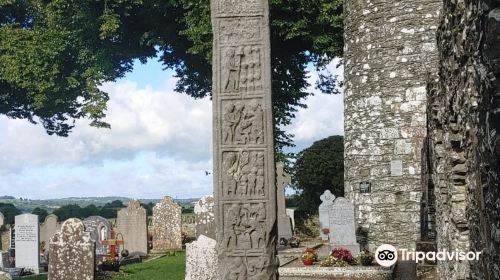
top-left (222, 99), bottom-right (264, 145)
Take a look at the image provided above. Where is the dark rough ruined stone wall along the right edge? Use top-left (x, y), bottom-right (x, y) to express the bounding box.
top-left (428, 0), bottom-right (500, 279)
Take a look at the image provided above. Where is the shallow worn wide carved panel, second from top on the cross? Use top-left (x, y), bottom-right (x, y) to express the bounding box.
top-left (219, 18), bottom-right (260, 45)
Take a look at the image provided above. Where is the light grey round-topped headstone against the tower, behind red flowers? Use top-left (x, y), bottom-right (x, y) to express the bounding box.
top-left (330, 197), bottom-right (359, 256)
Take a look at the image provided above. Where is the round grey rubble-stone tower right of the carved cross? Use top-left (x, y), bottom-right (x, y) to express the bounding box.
top-left (344, 0), bottom-right (442, 251)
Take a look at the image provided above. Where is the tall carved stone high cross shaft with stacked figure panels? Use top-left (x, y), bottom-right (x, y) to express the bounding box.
top-left (211, 0), bottom-right (278, 280)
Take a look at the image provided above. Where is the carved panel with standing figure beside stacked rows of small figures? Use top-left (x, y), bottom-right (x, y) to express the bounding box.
top-left (222, 46), bottom-right (262, 93)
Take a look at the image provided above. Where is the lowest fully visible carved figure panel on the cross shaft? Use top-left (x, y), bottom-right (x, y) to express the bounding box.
top-left (223, 202), bottom-right (267, 251)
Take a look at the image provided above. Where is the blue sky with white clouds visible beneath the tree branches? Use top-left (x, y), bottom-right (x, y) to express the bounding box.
top-left (0, 59), bottom-right (343, 199)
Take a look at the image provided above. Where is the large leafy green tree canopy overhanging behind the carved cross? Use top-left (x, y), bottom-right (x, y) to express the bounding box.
top-left (0, 0), bottom-right (343, 151)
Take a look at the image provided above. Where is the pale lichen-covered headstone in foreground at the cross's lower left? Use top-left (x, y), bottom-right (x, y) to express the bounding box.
top-left (185, 235), bottom-right (219, 280)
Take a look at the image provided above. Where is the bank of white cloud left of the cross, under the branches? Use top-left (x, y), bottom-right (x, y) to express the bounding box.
top-left (0, 81), bottom-right (212, 172)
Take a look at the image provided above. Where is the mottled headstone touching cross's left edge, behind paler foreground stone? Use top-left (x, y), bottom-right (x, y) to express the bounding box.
top-left (194, 196), bottom-right (215, 239)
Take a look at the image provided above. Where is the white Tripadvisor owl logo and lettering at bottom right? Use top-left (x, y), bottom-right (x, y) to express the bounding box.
top-left (375, 244), bottom-right (481, 267)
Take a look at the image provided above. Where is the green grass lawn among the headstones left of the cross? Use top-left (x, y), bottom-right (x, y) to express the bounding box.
top-left (22, 252), bottom-right (186, 280)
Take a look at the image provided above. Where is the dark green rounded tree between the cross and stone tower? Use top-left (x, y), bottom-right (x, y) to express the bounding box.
top-left (293, 136), bottom-right (344, 210)
